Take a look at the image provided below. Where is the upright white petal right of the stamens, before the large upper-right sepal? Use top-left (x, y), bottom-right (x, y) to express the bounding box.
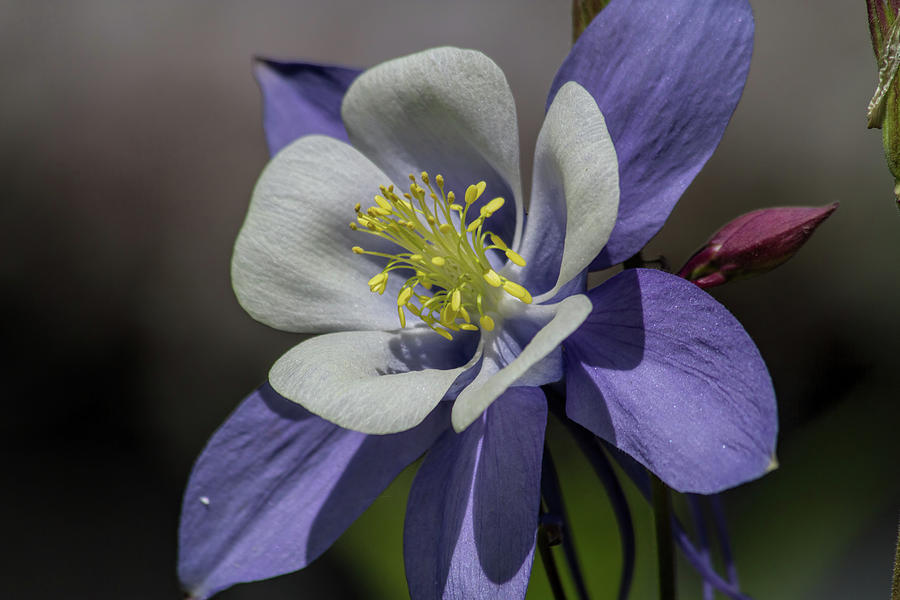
top-left (507, 82), bottom-right (619, 302)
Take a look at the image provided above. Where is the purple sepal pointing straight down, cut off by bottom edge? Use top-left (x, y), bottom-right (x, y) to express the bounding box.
top-left (403, 387), bottom-right (547, 600)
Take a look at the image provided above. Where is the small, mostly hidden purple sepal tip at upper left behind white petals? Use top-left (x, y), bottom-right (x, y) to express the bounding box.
top-left (253, 58), bottom-right (362, 156)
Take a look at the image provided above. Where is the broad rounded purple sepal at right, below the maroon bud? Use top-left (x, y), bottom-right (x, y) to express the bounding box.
top-left (565, 269), bottom-right (778, 494)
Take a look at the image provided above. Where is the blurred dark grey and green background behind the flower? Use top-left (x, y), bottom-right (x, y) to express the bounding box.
top-left (0, 0), bottom-right (900, 600)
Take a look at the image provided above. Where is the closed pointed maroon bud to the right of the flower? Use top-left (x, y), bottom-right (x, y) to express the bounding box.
top-left (678, 202), bottom-right (838, 288)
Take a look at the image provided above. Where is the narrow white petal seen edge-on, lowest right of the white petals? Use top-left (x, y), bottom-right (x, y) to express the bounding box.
top-left (453, 294), bottom-right (592, 431)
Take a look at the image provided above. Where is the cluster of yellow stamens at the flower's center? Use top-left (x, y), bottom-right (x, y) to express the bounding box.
top-left (350, 171), bottom-right (531, 340)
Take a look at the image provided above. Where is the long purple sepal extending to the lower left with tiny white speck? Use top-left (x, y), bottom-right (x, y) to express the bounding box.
top-left (178, 384), bottom-right (450, 600)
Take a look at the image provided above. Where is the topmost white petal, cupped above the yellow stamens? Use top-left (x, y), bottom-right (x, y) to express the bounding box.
top-left (341, 48), bottom-right (522, 244)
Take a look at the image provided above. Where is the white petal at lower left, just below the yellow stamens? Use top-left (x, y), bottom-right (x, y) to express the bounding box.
top-left (269, 327), bottom-right (480, 434)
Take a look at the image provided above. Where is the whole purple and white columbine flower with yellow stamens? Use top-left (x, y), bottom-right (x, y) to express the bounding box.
top-left (179, 0), bottom-right (776, 599)
